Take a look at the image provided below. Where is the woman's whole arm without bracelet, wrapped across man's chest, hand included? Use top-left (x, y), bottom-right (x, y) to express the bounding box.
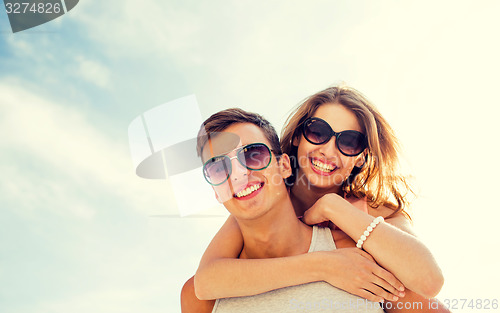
top-left (194, 217), bottom-right (403, 301)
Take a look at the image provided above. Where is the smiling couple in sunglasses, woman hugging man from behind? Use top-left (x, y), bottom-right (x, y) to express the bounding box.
top-left (181, 87), bottom-right (447, 313)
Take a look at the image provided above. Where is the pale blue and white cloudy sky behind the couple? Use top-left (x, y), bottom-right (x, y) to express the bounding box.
top-left (0, 0), bottom-right (500, 313)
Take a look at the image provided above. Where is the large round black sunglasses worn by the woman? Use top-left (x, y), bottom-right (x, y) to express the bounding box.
top-left (302, 117), bottom-right (368, 156)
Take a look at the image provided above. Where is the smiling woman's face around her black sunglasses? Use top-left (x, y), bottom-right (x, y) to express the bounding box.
top-left (293, 103), bottom-right (364, 192)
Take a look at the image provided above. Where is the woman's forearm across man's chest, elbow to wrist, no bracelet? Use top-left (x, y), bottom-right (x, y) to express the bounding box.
top-left (194, 253), bottom-right (323, 300)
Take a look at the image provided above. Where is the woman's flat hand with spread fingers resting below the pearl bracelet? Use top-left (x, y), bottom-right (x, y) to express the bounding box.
top-left (320, 248), bottom-right (405, 302)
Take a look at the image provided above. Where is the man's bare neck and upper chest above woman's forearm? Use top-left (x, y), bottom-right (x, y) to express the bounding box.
top-left (238, 197), bottom-right (312, 259)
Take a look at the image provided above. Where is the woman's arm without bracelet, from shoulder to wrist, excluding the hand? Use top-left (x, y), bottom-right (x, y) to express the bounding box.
top-left (194, 216), bottom-right (328, 300)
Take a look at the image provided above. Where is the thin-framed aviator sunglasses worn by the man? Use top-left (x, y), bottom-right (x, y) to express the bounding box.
top-left (203, 143), bottom-right (271, 186)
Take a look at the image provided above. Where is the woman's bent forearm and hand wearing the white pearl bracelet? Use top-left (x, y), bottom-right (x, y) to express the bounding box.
top-left (304, 194), bottom-right (444, 298)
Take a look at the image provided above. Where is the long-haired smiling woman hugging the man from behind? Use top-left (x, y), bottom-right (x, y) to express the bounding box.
top-left (183, 87), bottom-right (443, 310)
